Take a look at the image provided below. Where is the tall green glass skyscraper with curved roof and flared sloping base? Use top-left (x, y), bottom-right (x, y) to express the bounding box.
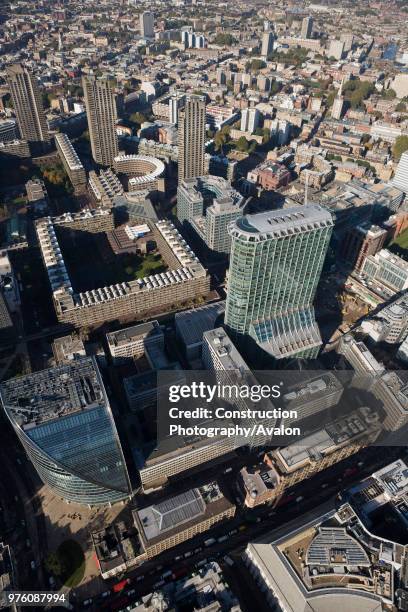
top-left (225, 205), bottom-right (333, 359)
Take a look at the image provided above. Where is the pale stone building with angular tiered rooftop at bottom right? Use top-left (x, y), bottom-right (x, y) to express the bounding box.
top-left (247, 506), bottom-right (383, 612)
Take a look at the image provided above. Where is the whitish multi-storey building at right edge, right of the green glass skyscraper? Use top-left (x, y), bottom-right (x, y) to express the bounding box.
top-left (360, 249), bottom-right (408, 296)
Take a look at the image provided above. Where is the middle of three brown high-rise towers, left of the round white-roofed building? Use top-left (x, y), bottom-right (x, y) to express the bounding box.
top-left (82, 75), bottom-right (118, 166)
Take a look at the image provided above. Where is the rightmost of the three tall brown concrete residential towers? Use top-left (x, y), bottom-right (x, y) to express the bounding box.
top-left (178, 95), bottom-right (206, 183)
